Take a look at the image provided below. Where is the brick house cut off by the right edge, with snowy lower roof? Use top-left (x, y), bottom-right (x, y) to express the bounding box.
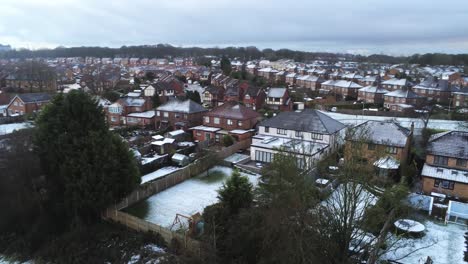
top-left (421, 131), bottom-right (468, 200)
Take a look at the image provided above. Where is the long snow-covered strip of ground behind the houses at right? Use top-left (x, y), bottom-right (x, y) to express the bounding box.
top-left (322, 111), bottom-right (468, 131)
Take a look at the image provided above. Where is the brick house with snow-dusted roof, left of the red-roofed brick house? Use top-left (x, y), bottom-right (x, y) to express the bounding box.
top-left (155, 99), bottom-right (208, 130)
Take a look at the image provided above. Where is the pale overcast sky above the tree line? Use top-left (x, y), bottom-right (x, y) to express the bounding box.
top-left (0, 0), bottom-right (468, 55)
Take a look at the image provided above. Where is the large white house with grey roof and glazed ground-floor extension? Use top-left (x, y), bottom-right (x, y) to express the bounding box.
top-left (250, 109), bottom-right (345, 168)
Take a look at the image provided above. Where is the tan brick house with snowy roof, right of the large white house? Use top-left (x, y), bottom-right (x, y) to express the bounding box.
top-left (344, 121), bottom-right (413, 180)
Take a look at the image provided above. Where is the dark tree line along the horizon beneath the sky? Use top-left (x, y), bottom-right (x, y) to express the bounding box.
top-left (0, 44), bottom-right (468, 65)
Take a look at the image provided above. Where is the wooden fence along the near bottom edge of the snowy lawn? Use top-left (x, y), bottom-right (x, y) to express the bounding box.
top-left (103, 209), bottom-right (201, 255)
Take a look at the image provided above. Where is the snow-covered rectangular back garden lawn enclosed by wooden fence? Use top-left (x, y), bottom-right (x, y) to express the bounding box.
top-left (125, 166), bottom-right (259, 227)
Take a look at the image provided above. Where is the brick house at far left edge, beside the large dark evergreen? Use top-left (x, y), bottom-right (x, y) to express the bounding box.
top-left (7, 93), bottom-right (51, 116)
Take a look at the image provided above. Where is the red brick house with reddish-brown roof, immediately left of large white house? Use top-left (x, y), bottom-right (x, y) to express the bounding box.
top-left (191, 102), bottom-right (260, 143)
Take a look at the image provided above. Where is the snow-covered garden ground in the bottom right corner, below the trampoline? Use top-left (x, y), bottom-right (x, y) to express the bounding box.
top-left (382, 220), bottom-right (467, 264)
